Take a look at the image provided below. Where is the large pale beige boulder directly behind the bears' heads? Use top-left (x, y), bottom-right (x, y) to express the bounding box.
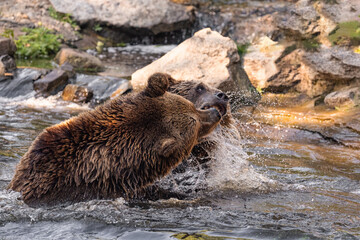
top-left (131, 28), bottom-right (259, 104)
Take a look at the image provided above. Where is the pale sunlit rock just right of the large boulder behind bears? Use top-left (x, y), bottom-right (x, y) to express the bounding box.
top-left (244, 37), bottom-right (285, 89)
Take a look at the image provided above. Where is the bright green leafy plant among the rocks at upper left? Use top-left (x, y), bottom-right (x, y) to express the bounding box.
top-left (15, 27), bottom-right (62, 58)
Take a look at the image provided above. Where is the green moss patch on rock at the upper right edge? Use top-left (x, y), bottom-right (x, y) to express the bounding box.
top-left (328, 21), bottom-right (360, 45)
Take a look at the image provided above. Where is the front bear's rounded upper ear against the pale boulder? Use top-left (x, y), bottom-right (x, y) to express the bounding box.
top-left (144, 73), bottom-right (175, 97)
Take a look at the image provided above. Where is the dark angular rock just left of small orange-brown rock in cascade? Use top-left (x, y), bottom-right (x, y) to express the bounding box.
top-left (34, 69), bottom-right (69, 96)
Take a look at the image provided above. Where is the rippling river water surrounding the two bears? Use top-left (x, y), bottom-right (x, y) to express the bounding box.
top-left (0, 46), bottom-right (360, 239)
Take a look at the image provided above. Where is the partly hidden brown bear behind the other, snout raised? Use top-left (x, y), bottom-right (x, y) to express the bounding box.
top-left (139, 79), bottom-right (238, 200)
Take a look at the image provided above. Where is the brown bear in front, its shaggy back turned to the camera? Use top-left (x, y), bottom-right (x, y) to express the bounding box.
top-left (9, 73), bottom-right (221, 206)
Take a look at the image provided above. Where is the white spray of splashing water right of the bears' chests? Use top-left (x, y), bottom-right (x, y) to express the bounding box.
top-left (206, 119), bottom-right (282, 193)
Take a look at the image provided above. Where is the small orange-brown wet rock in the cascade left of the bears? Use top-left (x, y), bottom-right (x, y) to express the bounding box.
top-left (61, 84), bottom-right (93, 103)
